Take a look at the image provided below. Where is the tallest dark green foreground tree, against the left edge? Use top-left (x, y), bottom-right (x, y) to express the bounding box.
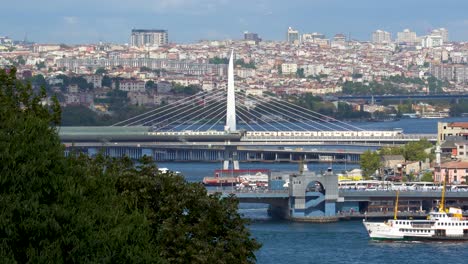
top-left (0, 69), bottom-right (157, 263)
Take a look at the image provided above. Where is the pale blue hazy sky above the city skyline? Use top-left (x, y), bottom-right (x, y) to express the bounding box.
top-left (0, 0), bottom-right (468, 44)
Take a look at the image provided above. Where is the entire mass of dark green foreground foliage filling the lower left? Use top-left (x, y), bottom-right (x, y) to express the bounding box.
top-left (0, 69), bottom-right (260, 263)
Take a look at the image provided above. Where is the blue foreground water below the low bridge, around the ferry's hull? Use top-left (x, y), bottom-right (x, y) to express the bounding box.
top-left (250, 221), bottom-right (468, 264)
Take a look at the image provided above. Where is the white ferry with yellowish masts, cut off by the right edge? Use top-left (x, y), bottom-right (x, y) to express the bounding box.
top-left (363, 184), bottom-right (468, 241)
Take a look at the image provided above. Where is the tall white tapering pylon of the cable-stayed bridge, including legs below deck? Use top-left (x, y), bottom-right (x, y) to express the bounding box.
top-left (223, 50), bottom-right (239, 170)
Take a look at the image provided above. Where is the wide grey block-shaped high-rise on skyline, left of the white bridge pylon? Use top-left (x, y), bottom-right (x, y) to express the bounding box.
top-left (130, 29), bottom-right (169, 47)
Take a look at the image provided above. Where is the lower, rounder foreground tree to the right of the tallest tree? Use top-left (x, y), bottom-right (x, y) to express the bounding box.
top-left (117, 157), bottom-right (260, 263)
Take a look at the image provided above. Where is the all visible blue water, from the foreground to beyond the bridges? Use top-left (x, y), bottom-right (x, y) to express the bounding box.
top-left (158, 118), bottom-right (468, 264)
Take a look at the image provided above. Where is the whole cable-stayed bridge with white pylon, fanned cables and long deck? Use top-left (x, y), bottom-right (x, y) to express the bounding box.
top-left (60, 51), bottom-right (436, 168)
